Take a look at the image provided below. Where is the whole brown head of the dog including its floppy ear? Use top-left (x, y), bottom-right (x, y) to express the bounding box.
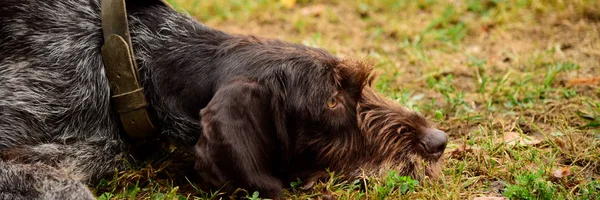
top-left (196, 37), bottom-right (447, 193)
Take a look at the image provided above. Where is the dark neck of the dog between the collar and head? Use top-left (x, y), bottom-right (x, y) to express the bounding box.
top-left (128, 6), bottom-right (230, 145)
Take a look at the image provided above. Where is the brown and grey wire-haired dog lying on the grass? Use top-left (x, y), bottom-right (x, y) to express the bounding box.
top-left (0, 0), bottom-right (447, 199)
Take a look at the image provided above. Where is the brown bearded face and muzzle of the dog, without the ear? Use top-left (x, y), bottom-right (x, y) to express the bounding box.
top-left (270, 49), bottom-right (448, 179)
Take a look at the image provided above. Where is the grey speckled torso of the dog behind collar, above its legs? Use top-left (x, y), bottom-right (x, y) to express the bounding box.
top-left (0, 0), bottom-right (118, 149)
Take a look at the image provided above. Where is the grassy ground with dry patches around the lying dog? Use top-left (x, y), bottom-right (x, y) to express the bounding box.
top-left (95, 0), bottom-right (600, 199)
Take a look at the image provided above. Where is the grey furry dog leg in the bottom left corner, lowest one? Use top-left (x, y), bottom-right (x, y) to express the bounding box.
top-left (0, 161), bottom-right (95, 200)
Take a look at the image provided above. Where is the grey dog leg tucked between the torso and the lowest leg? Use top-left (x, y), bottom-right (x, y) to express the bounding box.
top-left (1, 140), bottom-right (125, 182)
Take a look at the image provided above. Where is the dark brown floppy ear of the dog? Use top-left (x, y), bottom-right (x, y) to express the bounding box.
top-left (195, 80), bottom-right (282, 198)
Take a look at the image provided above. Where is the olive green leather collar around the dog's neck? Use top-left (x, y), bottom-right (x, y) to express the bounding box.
top-left (101, 0), bottom-right (166, 140)
